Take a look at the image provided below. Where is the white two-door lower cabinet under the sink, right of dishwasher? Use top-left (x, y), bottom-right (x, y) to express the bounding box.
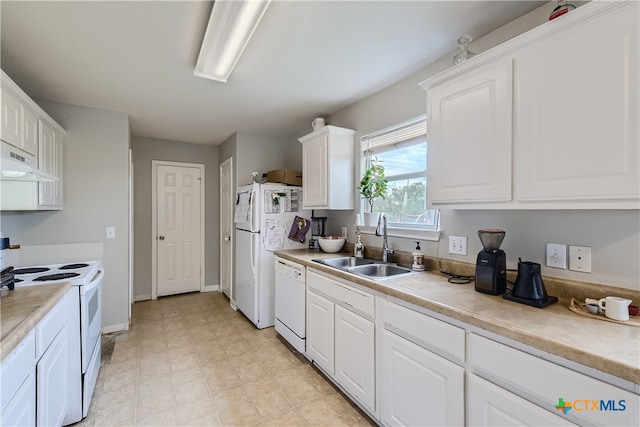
top-left (307, 270), bottom-right (376, 414)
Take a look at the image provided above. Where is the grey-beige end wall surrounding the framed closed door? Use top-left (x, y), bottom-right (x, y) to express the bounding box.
top-left (131, 137), bottom-right (220, 299)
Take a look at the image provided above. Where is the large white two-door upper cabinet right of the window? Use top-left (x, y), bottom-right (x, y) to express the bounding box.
top-left (421, 1), bottom-right (640, 209)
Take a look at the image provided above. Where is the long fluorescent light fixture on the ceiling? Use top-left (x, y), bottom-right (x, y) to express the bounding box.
top-left (194, 0), bottom-right (271, 83)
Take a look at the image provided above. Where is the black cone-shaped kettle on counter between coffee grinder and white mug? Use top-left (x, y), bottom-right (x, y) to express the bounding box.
top-left (503, 258), bottom-right (558, 308)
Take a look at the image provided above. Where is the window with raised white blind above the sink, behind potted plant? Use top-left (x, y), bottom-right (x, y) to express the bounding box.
top-left (361, 116), bottom-right (439, 230)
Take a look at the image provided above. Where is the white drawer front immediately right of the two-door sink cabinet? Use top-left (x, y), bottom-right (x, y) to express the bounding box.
top-left (384, 301), bottom-right (465, 363)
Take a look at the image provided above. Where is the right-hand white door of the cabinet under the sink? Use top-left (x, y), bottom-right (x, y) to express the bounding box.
top-left (335, 305), bottom-right (375, 412)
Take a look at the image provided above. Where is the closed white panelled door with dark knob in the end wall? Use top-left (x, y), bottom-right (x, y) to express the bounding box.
top-left (156, 165), bottom-right (203, 296)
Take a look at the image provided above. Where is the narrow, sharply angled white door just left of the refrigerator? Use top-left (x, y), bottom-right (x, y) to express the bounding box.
top-left (220, 157), bottom-right (235, 306)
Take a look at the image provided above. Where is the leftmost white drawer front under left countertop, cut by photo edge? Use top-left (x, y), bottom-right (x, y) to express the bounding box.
top-left (0, 331), bottom-right (36, 410)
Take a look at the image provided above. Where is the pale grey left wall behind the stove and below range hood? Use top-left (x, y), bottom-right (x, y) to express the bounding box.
top-left (2, 102), bottom-right (130, 330)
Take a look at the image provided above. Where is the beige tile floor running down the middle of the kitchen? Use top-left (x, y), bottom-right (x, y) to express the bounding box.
top-left (76, 292), bottom-right (375, 427)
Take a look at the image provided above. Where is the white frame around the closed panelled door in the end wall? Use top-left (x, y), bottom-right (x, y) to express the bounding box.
top-left (151, 160), bottom-right (206, 300)
